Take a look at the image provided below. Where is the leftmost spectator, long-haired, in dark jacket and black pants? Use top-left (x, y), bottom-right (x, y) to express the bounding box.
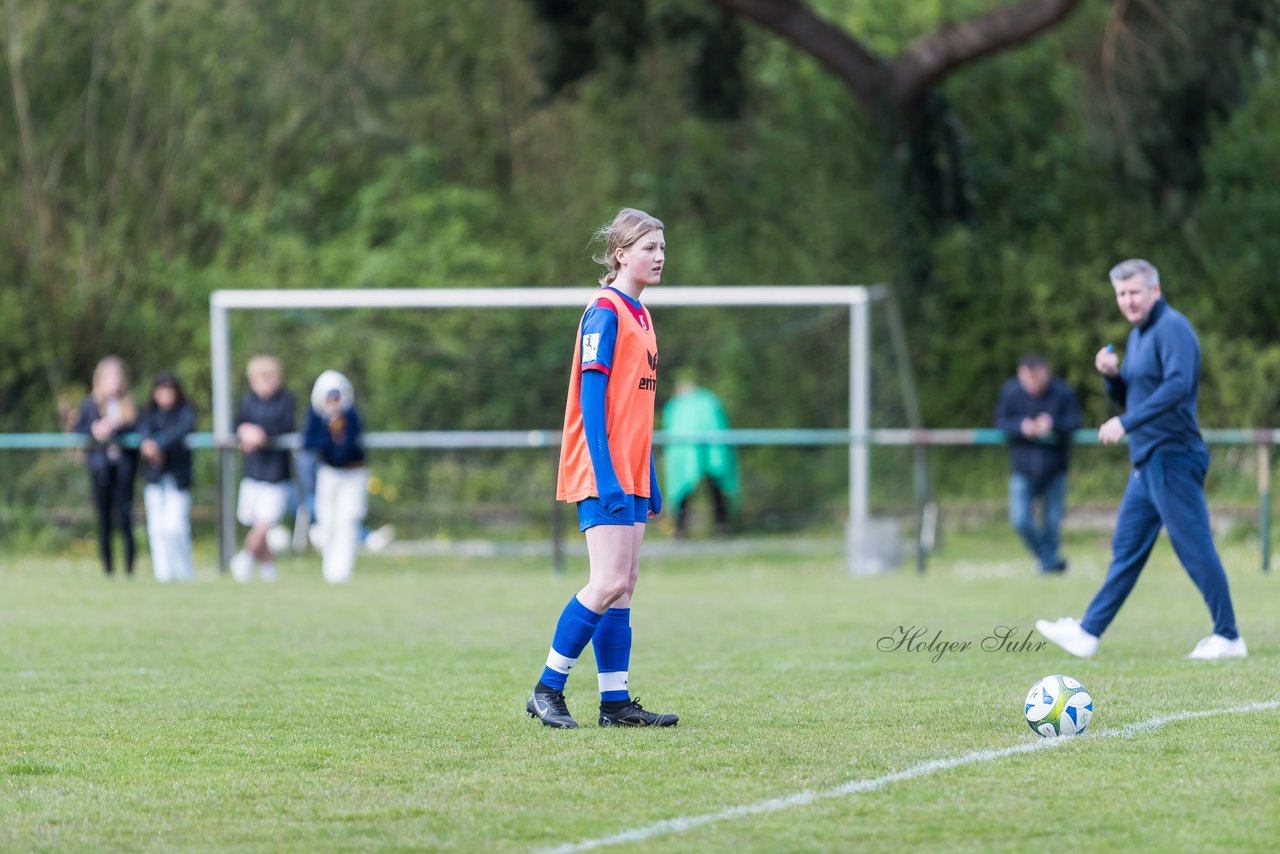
top-left (74, 356), bottom-right (138, 576)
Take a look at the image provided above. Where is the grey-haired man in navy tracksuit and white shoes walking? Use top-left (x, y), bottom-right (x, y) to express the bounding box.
top-left (1036, 259), bottom-right (1248, 658)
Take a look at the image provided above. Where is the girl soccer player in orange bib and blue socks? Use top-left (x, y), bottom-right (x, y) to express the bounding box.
top-left (525, 207), bottom-right (680, 729)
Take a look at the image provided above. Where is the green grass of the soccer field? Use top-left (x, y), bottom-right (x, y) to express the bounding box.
top-left (0, 529), bottom-right (1280, 851)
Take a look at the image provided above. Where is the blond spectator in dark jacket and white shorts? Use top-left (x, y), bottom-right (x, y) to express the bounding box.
top-left (230, 356), bottom-right (298, 581)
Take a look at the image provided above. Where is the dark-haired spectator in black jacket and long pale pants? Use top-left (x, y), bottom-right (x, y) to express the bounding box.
top-left (138, 373), bottom-right (196, 583)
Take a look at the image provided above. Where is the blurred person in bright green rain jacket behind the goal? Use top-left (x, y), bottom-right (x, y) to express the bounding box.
top-left (662, 378), bottom-right (739, 539)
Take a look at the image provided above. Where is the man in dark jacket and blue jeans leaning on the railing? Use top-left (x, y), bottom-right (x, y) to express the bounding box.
top-left (996, 355), bottom-right (1080, 572)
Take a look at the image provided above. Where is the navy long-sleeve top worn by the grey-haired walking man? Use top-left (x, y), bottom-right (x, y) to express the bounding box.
top-left (1106, 300), bottom-right (1204, 466)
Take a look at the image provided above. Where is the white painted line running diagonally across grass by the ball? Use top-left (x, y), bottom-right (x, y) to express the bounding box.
top-left (544, 700), bottom-right (1280, 854)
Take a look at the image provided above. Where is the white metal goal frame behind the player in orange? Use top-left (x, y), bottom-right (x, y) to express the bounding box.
top-left (210, 284), bottom-right (918, 574)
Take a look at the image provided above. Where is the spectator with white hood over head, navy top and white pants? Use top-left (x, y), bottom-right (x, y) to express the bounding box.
top-left (303, 370), bottom-right (369, 584)
